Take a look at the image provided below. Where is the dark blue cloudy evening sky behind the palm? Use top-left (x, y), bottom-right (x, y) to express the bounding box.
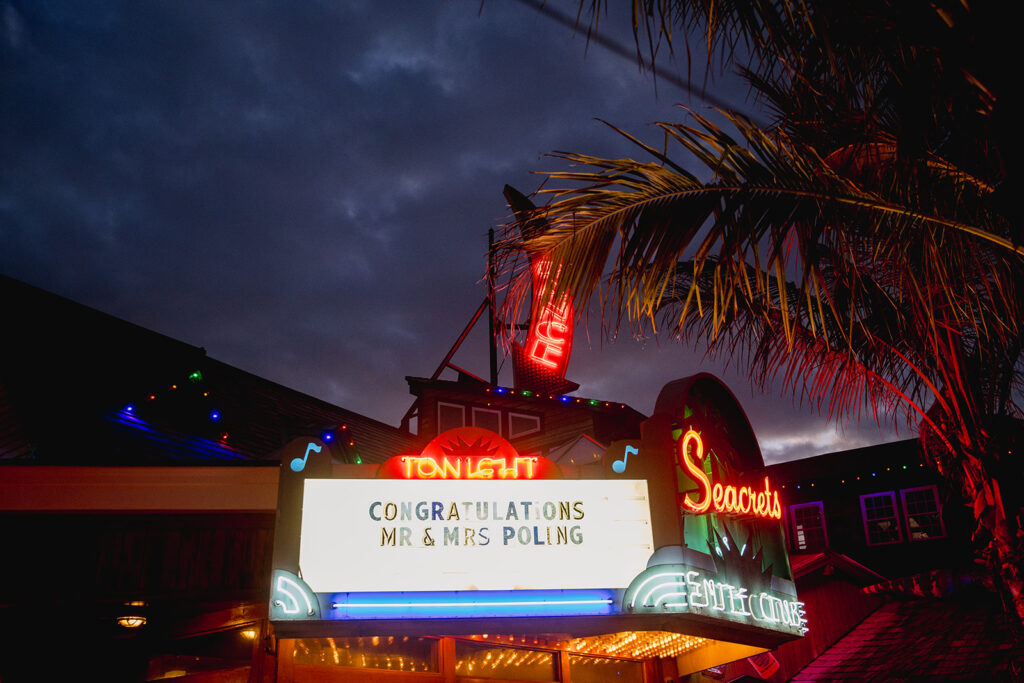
top-left (0, 0), bottom-right (897, 461)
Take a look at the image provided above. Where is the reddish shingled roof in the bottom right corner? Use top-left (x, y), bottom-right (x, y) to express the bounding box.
top-left (791, 590), bottom-right (1024, 682)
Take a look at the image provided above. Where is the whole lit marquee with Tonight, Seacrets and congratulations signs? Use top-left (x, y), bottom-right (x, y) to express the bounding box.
top-left (270, 376), bottom-right (806, 646)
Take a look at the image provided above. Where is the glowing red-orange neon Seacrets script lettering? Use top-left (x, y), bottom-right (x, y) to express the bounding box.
top-left (679, 429), bottom-right (782, 519)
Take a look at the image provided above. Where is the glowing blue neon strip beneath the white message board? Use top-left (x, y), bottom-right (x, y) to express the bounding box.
top-left (326, 590), bottom-right (615, 620)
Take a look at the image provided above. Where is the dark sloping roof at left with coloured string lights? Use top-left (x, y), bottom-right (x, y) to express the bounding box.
top-left (0, 275), bottom-right (417, 465)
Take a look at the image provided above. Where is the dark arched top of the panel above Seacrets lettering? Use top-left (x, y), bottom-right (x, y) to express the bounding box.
top-left (654, 373), bottom-right (764, 470)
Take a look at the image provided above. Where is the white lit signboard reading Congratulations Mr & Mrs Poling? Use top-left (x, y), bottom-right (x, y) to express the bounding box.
top-left (299, 479), bottom-right (654, 593)
